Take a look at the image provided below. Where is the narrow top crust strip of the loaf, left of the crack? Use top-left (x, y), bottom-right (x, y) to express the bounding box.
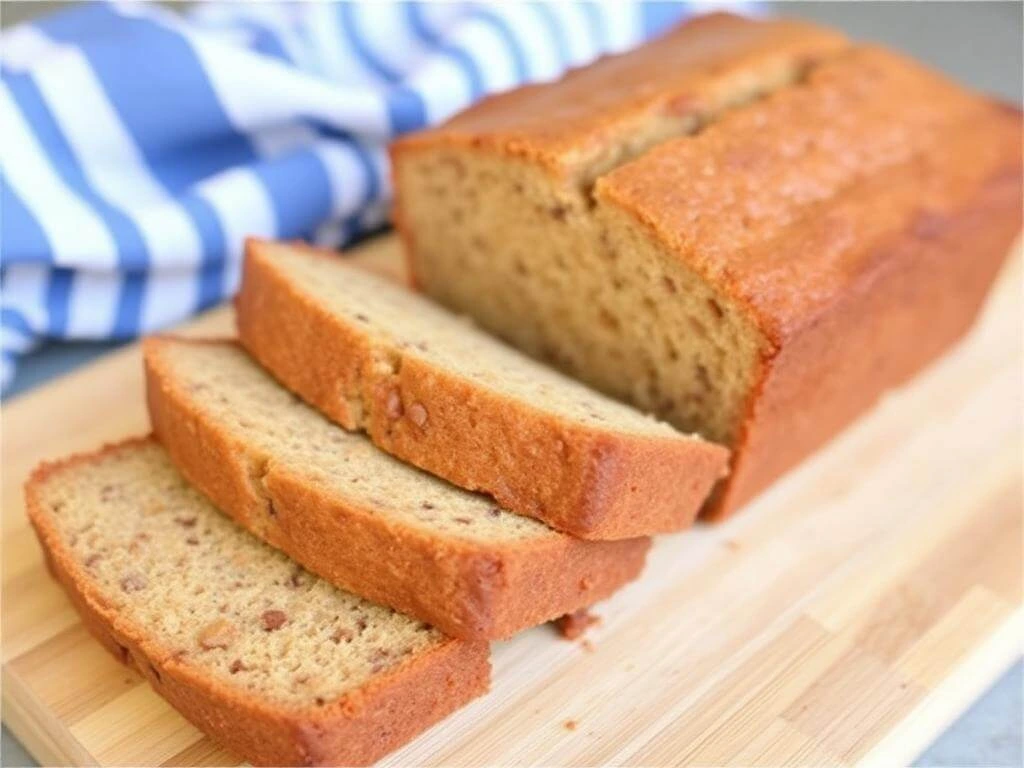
top-left (393, 13), bottom-right (848, 175)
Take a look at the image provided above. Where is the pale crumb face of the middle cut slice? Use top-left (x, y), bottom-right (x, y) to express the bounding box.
top-left (161, 341), bottom-right (557, 543)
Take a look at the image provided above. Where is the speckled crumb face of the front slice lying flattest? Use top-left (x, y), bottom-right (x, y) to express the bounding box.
top-left (40, 442), bottom-right (445, 707)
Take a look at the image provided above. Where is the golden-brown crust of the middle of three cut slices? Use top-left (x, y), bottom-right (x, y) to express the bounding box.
top-left (144, 338), bottom-right (650, 639)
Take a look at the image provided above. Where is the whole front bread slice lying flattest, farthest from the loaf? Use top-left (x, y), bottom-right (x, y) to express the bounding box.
top-left (26, 439), bottom-right (489, 765)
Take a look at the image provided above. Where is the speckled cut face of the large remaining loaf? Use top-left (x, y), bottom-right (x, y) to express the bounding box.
top-left (398, 147), bottom-right (766, 444)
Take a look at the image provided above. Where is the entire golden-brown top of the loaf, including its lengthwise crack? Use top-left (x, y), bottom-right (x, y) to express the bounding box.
top-left (387, 14), bottom-right (1021, 348)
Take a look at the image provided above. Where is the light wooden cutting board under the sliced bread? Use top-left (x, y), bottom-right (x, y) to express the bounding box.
top-left (2, 239), bottom-right (1024, 765)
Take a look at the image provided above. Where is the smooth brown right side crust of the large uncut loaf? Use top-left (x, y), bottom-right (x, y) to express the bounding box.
top-left (703, 124), bottom-right (1024, 520)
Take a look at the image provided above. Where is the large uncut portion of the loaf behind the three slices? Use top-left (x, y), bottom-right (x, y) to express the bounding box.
top-left (392, 14), bottom-right (1021, 516)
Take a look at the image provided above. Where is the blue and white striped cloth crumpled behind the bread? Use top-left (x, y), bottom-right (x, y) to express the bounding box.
top-left (0, 0), bottom-right (753, 387)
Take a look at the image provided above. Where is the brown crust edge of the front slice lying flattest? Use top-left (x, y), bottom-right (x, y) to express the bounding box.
top-left (26, 438), bottom-right (489, 765)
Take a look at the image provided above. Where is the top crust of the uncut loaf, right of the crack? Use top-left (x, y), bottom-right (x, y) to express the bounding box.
top-left (594, 46), bottom-right (1021, 347)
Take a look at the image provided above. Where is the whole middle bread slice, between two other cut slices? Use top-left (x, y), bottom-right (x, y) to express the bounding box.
top-left (144, 338), bottom-right (649, 639)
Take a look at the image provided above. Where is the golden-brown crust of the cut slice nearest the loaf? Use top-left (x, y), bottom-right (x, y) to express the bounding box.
top-left (236, 240), bottom-right (728, 540)
